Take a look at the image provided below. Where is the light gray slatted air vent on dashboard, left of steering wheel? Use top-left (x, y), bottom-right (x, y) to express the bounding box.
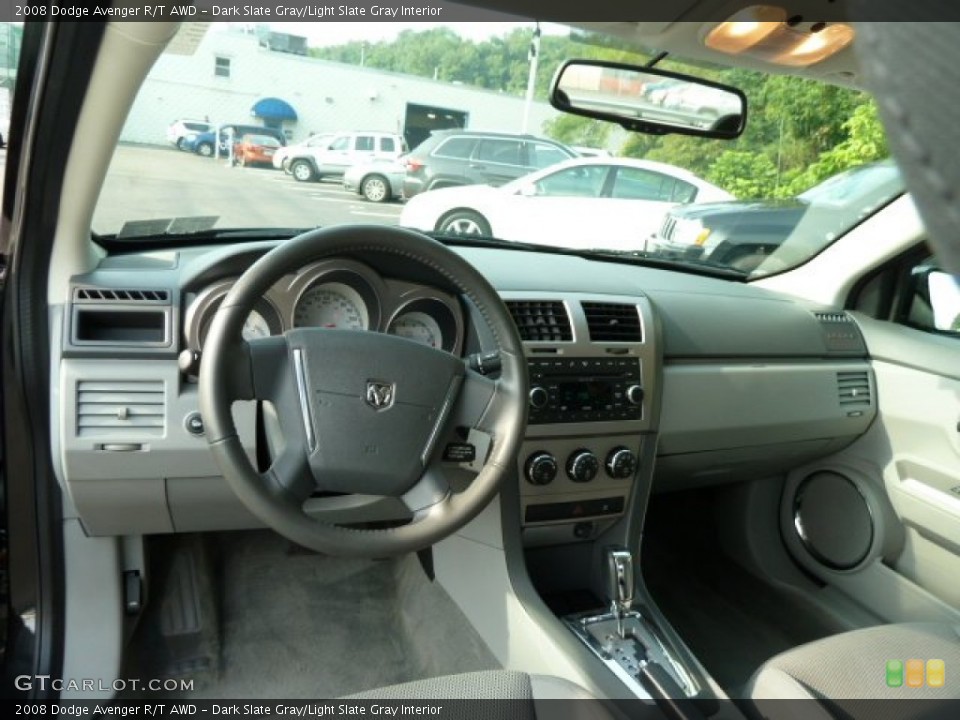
top-left (77, 380), bottom-right (164, 438)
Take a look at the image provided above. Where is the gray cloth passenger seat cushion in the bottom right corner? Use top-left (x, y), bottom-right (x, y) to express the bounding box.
top-left (744, 623), bottom-right (960, 718)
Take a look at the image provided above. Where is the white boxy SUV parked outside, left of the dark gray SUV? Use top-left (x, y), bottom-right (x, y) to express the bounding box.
top-left (287, 132), bottom-right (407, 182)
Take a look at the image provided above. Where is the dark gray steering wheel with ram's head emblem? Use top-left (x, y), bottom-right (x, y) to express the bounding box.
top-left (199, 226), bottom-right (527, 557)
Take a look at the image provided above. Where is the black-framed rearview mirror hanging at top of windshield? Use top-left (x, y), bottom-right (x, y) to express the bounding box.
top-left (550, 60), bottom-right (747, 139)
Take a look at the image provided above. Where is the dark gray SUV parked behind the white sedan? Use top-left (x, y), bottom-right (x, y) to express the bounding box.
top-left (403, 130), bottom-right (577, 198)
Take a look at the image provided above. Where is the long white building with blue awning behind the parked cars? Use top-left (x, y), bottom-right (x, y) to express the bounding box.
top-left (121, 29), bottom-right (556, 146)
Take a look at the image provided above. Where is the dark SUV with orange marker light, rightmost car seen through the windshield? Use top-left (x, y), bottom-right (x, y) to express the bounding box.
top-left (647, 160), bottom-right (904, 272)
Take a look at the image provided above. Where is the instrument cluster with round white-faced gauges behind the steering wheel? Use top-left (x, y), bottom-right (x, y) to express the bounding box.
top-left (184, 259), bottom-right (463, 354)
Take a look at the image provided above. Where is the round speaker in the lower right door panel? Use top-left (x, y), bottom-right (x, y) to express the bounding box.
top-left (793, 470), bottom-right (874, 570)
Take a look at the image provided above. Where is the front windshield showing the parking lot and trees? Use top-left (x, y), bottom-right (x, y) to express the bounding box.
top-left (93, 22), bottom-right (903, 277)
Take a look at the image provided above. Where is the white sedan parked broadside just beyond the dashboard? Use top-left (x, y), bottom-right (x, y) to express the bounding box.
top-left (400, 157), bottom-right (734, 250)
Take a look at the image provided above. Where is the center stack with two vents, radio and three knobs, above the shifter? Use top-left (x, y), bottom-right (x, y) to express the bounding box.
top-left (501, 292), bottom-right (657, 546)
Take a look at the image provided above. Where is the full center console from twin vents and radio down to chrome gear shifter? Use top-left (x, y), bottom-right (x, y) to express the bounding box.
top-left (504, 293), bottom-right (710, 718)
